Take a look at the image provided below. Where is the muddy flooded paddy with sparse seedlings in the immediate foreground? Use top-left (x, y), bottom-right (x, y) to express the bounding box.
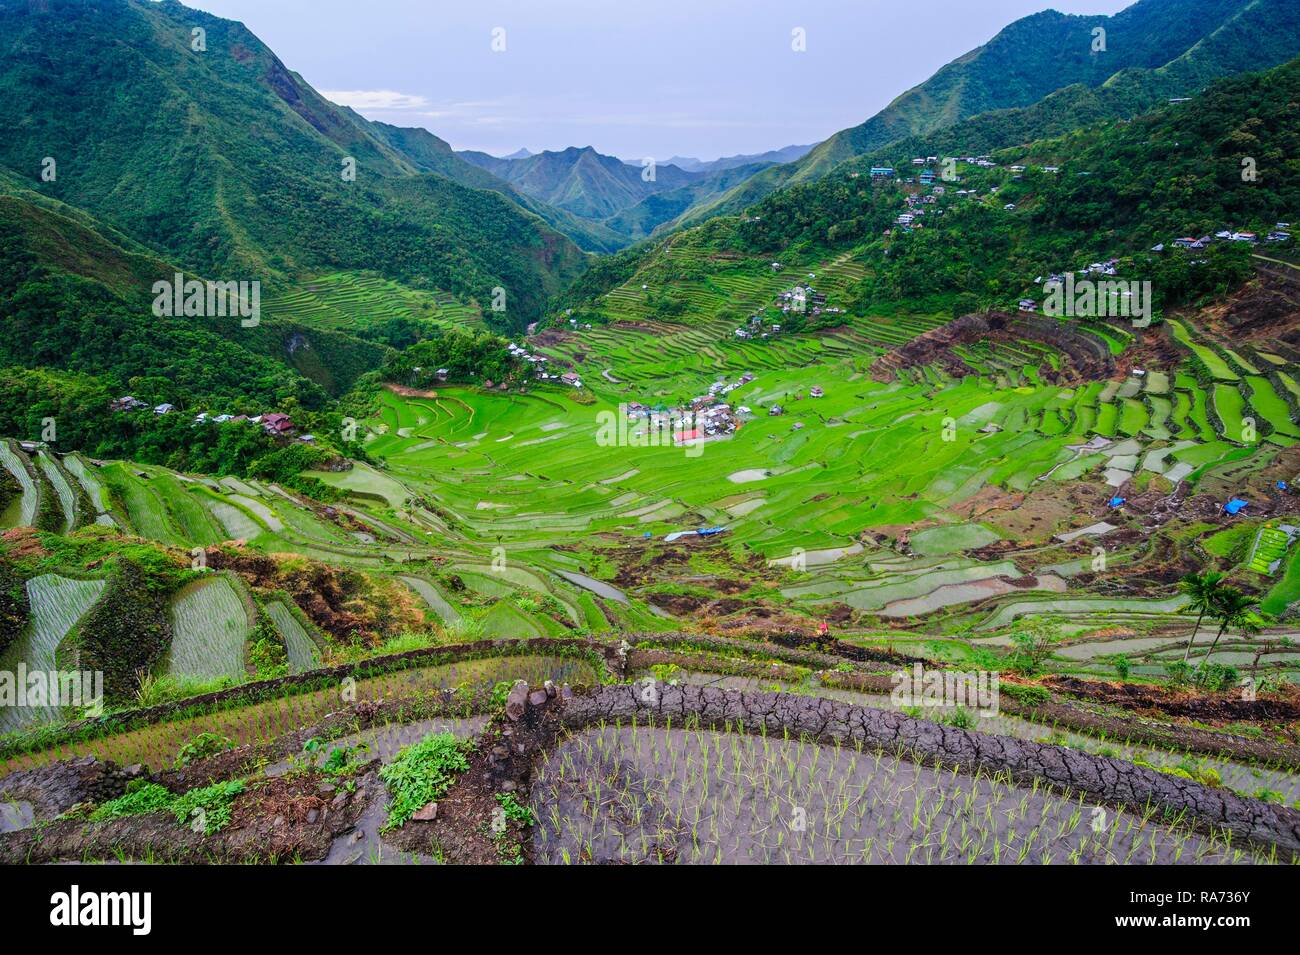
top-left (532, 725), bottom-right (1251, 865)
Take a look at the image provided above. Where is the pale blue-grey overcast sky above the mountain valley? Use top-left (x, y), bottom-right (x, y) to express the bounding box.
top-left (187, 0), bottom-right (1131, 160)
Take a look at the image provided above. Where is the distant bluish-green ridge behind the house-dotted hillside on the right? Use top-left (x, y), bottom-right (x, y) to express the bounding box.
top-left (675, 0), bottom-right (1300, 225)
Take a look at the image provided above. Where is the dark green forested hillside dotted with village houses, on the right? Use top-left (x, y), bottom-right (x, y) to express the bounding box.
top-left (579, 57), bottom-right (1300, 327)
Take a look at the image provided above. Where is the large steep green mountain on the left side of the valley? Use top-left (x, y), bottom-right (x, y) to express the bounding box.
top-left (0, 0), bottom-right (586, 324)
